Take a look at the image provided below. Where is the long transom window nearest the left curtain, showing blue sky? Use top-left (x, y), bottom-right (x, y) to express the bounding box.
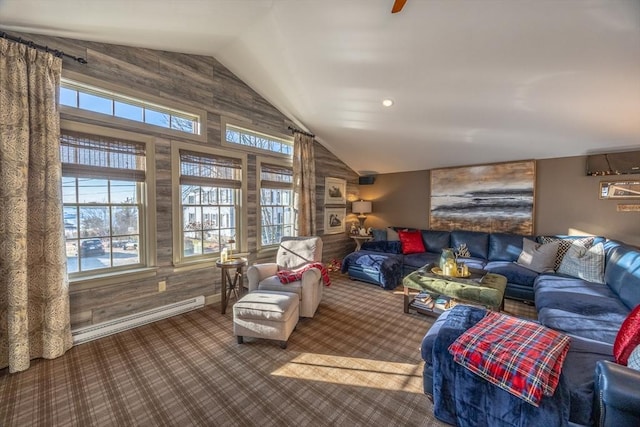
top-left (60, 78), bottom-right (201, 135)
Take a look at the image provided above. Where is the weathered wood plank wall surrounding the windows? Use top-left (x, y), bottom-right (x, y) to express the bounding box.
top-left (11, 32), bottom-right (358, 328)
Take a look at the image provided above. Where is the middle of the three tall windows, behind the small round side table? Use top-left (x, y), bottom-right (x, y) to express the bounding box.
top-left (174, 148), bottom-right (243, 263)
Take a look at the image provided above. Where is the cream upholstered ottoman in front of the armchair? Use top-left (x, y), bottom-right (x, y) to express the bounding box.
top-left (233, 291), bottom-right (300, 348)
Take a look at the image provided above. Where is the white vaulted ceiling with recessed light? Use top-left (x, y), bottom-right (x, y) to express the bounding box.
top-left (0, 0), bottom-right (640, 174)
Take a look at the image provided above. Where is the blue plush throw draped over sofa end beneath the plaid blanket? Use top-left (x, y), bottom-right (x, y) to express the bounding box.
top-left (432, 305), bottom-right (569, 427)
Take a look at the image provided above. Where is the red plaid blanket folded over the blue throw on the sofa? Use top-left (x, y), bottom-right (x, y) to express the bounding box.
top-left (449, 312), bottom-right (570, 407)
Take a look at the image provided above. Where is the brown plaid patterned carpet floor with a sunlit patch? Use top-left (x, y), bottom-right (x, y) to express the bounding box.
top-left (0, 274), bottom-right (535, 427)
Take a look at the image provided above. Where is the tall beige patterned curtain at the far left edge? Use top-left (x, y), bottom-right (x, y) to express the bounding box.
top-left (0, 39), bottom-right (72, 372)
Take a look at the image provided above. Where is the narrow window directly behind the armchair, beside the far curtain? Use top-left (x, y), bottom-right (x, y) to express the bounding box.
top-left (258, 161), bottom-right (296, 247)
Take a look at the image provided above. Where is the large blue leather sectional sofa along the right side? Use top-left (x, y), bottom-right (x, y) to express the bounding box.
top-left (342, 230), bottom-right (640, 427)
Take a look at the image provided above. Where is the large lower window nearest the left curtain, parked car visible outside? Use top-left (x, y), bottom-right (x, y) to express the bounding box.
top-left (60, 129), bottom-right (147, 278)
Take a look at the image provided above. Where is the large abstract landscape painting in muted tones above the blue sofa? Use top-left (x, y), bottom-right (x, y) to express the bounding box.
top-left (429, 160), bottom-right (536, 234)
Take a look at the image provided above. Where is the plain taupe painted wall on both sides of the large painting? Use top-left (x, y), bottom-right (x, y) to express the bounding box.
top-left (360, 156), bottom-right (640, 246)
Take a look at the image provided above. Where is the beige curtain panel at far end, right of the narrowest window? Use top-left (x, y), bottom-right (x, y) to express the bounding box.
top-left (293, 132), bottom-right (316, 236)
